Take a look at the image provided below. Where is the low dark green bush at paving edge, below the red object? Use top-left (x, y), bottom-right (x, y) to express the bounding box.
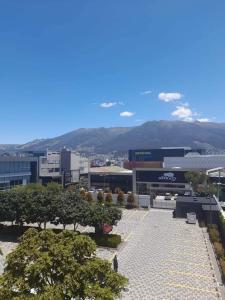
top-left (89, 233), bottom-right (122, 248)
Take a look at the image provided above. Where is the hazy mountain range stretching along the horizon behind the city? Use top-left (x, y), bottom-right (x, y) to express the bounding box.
top-left (0, 121), bottom-right (225, 153)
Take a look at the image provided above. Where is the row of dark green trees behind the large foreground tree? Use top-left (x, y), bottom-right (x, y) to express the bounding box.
top-left (0, 184), bottom-right (122, 233)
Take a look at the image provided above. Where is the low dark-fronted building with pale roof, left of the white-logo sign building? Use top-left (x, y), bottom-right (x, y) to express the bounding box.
top-left (88, 166), bottom-right (133, 193)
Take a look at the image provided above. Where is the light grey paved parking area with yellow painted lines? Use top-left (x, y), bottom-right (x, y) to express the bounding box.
top-left (0, 209), bottom-right (224, 300)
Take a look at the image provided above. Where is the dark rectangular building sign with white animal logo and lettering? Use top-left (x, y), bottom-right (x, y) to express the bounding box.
top-left (136, 170), bottom-right (187, 183)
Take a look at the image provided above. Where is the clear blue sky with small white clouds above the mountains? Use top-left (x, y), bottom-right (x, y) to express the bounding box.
top-left (0, 0), bottom-right (225, 143)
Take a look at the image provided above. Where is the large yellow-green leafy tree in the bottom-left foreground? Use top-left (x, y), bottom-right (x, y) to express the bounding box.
top-left (0, 229), bottom-right (127, 300)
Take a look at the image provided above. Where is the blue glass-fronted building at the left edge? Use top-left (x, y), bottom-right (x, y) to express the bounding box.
top-left (0, 156), bottom-right (38, 190)
